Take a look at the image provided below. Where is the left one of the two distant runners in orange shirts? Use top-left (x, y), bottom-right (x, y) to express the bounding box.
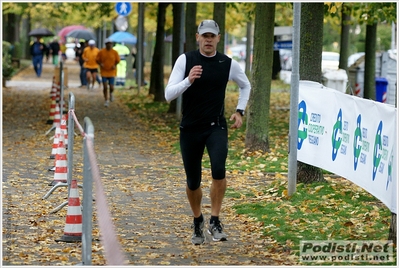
top-left (82, 40), bottom-right (100, 89)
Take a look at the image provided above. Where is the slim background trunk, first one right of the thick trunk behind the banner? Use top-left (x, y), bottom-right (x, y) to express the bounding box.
top-left (339, 3), bottom-right (351, 70)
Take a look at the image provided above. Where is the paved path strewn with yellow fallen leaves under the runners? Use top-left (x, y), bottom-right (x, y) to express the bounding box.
top-left (2, 61), bottom-right (296, 265)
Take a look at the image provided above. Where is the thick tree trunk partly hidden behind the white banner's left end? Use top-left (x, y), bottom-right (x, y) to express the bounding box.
top-left (297, 3), bottom-right (325, 183)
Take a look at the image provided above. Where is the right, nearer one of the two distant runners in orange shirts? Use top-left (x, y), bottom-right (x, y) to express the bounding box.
top-left (96, 39), bottom-right (121, 107)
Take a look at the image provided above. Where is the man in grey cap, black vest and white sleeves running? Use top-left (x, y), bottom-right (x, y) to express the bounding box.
top-left (165, 20), bottom-right (251, 245)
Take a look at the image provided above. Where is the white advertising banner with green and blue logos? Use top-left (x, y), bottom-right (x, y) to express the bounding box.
top-left (298, 81), bottom-right (398, 213)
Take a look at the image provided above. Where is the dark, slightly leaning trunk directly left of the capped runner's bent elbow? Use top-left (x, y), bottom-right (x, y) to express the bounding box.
top-left (149, 3), bottom-right (169, 102)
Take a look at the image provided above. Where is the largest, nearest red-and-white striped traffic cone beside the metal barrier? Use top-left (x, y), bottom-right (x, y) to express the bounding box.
top-left (55, 179), bottom-right (82, 242)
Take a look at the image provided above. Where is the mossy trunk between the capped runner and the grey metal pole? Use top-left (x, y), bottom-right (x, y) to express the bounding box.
top-left (245, 3), bottom-right (275, 152)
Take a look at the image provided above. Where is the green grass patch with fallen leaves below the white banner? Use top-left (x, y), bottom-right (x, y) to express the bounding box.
top-left (233, 179), bottom-right (396, 265)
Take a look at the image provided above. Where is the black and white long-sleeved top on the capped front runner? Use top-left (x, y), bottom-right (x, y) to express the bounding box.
top-left (165, 50), bottom-right (251, 128)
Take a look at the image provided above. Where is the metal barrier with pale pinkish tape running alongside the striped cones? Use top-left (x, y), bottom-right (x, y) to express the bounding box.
top-left (43, 64), bottom-right (127, 265)
